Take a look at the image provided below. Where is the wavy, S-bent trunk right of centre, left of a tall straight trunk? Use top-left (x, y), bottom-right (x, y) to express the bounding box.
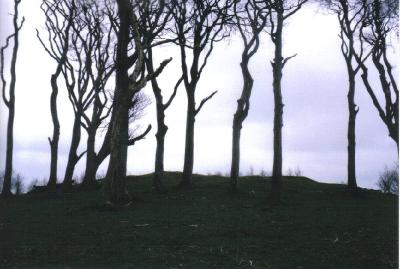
top-left (231, 59), bottom-right (253, 192)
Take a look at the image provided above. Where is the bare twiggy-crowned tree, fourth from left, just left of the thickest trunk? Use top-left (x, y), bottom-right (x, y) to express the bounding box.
top-left (81, 1), bottom-right (115, 186)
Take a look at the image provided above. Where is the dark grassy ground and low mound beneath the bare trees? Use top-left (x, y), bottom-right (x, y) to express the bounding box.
top-left (0, 173), bottom-right (398, 269)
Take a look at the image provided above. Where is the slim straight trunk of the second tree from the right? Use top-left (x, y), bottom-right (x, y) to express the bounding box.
top-left (347, 74), bottom-right (358, 191)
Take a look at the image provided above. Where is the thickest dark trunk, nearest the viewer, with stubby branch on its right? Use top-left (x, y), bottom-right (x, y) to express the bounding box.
top-left (104, 0), bottom-right (171, 204)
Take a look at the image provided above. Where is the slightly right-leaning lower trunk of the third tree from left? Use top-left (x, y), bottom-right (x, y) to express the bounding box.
top-left (63, 114), bottom-right (81, 188)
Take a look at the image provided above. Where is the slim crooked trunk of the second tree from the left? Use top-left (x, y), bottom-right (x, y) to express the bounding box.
top-left (47, 73), bottom-right (61, 188)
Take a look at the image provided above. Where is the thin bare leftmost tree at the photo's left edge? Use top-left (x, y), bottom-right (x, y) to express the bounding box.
top-left (0, 0), bottom-right (25, 197)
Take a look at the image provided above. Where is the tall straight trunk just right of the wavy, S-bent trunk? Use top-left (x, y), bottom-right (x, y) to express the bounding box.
top-left (271, 13), bottom-right (284, 203)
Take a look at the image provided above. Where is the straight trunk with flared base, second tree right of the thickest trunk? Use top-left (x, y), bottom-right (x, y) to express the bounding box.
top-left (178, 92), bottom-right (196, 189)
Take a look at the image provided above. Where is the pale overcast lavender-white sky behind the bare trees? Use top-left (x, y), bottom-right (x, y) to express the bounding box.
top-left (0, 0), bottom-right (398, 188)
